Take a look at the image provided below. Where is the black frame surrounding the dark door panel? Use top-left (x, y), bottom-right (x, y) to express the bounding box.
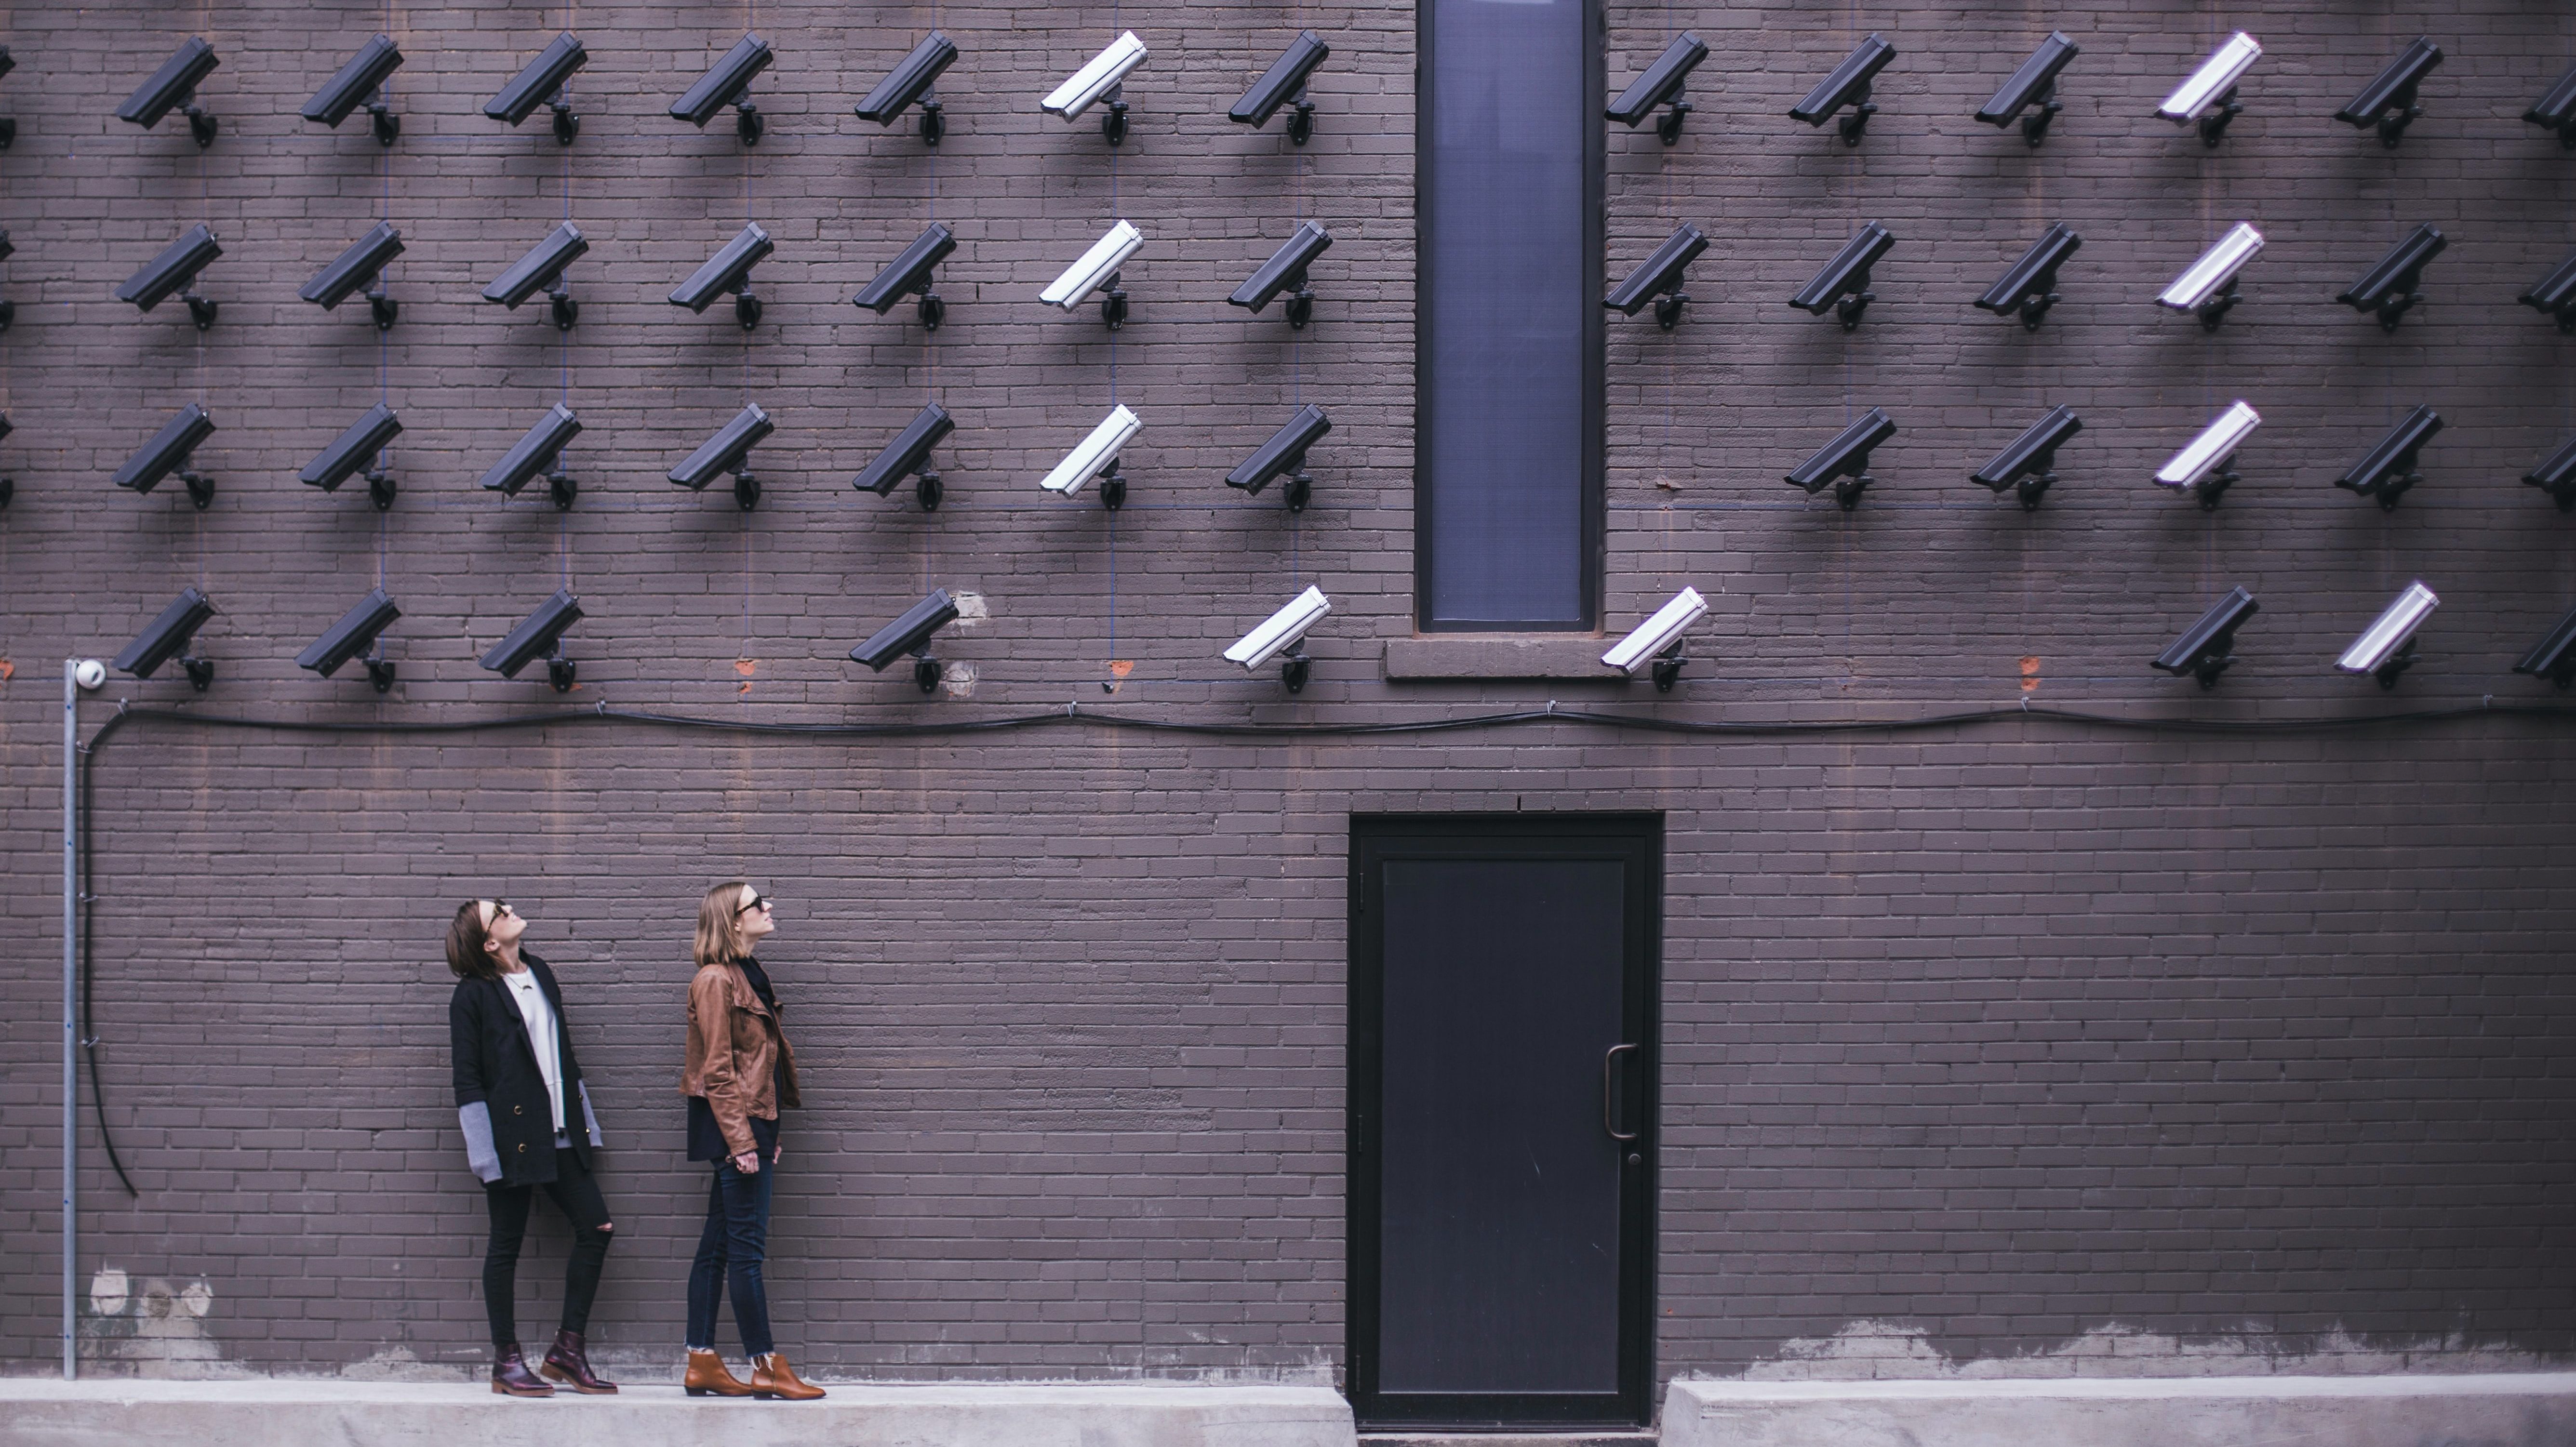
top-left (1342, 814), bottom-right (1664, 1429)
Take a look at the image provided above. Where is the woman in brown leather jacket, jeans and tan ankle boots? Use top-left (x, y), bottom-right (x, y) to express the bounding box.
top-left (680, 880), bottom-right (822, 1401)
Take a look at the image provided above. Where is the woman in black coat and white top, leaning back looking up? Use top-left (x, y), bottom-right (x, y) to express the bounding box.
top-left (448, 899), bottom-right (618, 1395)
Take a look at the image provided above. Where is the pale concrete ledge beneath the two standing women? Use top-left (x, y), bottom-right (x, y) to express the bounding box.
top-left (0, 1380), bottom-right (1355, 1447)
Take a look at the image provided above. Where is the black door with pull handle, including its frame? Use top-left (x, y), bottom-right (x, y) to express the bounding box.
top-left (1350, 814), bottom-right (1662, 1426)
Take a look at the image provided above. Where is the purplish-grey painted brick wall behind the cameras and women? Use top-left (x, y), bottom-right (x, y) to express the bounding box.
top-left (0, 2), bottom-right (2576, 1375)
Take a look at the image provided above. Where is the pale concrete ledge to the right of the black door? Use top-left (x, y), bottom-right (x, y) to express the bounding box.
top-left (1664, 1372), bottom-right (2576, 1447)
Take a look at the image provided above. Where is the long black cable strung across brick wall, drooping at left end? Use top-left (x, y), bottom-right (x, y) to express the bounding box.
top-left (77, 685), bottom-right (2576, 1195)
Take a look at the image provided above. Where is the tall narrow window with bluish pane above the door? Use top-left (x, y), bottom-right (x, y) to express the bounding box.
top-left (1414, 0), bottom-right (1602, 631)
